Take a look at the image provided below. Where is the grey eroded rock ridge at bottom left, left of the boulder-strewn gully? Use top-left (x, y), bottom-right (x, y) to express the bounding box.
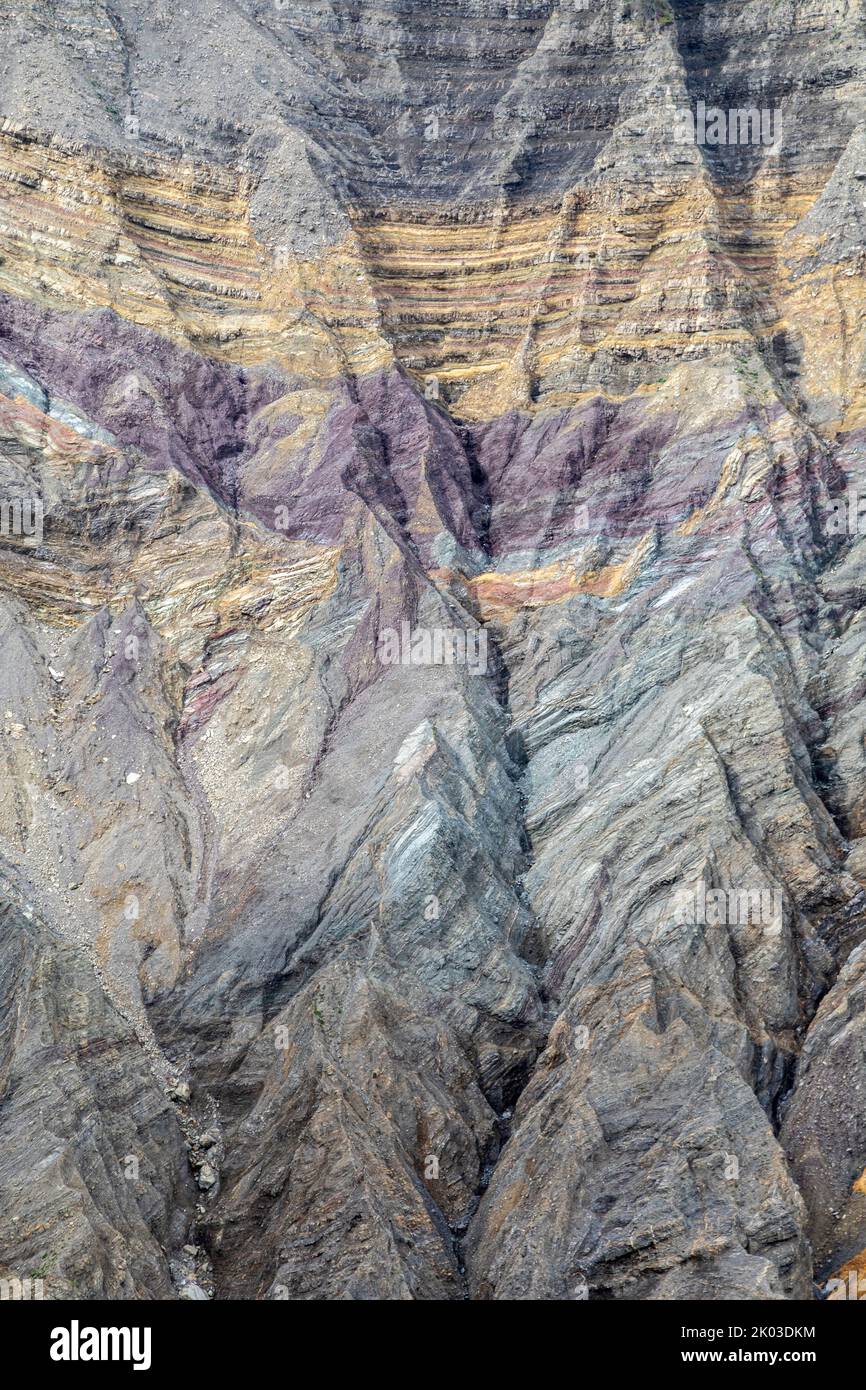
top-left (0, 908), bottom-right (192, 1298)
